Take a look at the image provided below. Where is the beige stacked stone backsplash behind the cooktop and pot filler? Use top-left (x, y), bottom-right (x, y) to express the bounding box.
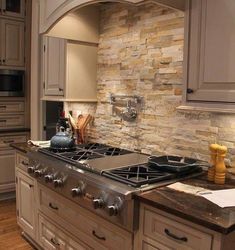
top-left (66, 3), bottom-right (235, 165)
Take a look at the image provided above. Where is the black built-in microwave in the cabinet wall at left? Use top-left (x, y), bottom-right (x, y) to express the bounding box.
top-left (0, 69), bottom-right (25, 96)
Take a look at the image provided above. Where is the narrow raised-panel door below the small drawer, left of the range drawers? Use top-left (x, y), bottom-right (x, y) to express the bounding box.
top-left (16, 171), bottom-right (35, 238)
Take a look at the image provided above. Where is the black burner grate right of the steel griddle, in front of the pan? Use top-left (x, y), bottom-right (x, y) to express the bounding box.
top-left (102, 163), bottom-right (175, 187)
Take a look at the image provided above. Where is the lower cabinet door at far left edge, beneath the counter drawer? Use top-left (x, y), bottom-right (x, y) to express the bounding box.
top-left (0, 150), bottom-right (15, 193)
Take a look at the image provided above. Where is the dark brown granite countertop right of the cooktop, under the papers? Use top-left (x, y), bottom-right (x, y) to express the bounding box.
top-left (135, 174), bottom-right (235, 234)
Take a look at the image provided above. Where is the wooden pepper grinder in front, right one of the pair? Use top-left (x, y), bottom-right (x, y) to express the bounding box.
top-left (215, 146), bottom-right (227, 184)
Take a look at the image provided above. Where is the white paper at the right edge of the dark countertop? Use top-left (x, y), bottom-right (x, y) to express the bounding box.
top-left (199, 188), bottom-right (235, 208)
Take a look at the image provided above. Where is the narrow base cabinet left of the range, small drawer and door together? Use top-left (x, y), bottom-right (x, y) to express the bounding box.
top-left (16, 154), bottom-right (36, 239)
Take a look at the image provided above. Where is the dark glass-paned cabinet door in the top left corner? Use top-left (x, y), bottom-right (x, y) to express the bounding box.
top-left (2, 0), bottom-right (25, 18)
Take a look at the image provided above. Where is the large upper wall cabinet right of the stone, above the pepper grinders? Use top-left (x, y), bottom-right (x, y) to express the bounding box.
top-left (185, 0), bottom-right (235, 103)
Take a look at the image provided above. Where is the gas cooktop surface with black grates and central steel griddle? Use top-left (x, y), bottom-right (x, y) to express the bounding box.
top-left (39, 143), bottom-right (202, 187)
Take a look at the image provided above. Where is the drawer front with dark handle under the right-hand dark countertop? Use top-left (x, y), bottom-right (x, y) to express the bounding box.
top-left (143, 207), bottom-right (212, 250)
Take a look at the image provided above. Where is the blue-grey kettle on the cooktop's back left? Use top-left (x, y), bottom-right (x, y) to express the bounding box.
top-left (50, 127), bottom-right (75, 151)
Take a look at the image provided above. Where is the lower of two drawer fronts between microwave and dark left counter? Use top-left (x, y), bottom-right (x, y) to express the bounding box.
top-left (0, 115), bottom-right (24, 129)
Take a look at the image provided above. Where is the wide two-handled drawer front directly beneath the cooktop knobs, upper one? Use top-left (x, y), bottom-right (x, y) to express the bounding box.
top-left (39, 185), bottom-right (132, 250)
